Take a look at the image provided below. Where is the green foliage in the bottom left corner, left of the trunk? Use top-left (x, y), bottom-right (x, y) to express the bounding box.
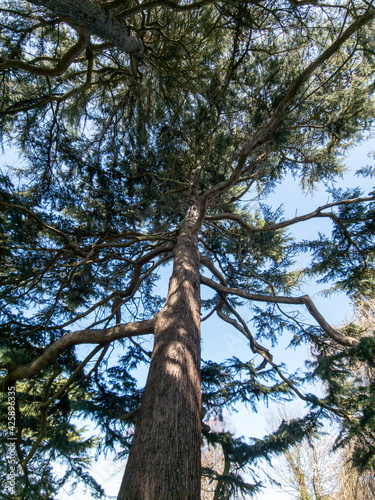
top-left (0, 372), bottom-right (103, 500)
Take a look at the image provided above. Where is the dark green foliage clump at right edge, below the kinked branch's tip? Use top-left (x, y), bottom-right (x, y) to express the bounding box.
top-left (313, 308), bottom-right (375, 471)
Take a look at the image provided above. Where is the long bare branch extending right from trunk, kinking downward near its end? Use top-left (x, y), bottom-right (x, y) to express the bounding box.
top-left (201, 276), bottom-right (359, 346)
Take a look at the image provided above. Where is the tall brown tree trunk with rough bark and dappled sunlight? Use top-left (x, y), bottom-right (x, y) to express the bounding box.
top-left (118, 206), bottom-right (201, 500)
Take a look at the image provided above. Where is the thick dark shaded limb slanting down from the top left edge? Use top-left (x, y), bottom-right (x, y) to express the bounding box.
top-left (29, 0), bottom-right (143, 53)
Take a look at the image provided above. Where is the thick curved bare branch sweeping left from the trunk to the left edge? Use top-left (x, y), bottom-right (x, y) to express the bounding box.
top-left (0, 318), bottom-right (154, 391)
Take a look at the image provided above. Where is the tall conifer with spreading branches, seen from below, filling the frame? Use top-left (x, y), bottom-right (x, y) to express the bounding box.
top-left (0, 0), bottom-right (375, 500)
